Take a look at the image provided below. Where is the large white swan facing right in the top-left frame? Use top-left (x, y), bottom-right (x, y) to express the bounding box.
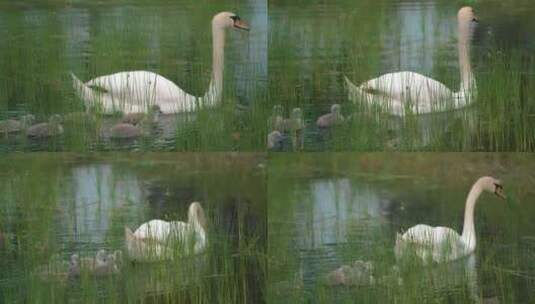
top-left (71, 12), bottom-right (249, 114)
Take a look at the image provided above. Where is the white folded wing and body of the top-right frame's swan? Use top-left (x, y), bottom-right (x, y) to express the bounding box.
top-left (359, 72), bottom-right (455, 115)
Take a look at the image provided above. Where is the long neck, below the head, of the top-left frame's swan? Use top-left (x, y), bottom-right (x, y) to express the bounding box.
top-left (202, 24), bottom-right (225, 106)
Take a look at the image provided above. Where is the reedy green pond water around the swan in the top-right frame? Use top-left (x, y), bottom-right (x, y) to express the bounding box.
top-left (269, 0), bottom-right (535, 151)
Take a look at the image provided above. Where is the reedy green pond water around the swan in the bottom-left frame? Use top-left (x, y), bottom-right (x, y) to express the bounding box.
top-left (0, 153), bottom-right (267, 303)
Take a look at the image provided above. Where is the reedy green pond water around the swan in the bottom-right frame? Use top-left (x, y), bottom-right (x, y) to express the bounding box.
top-left (268, 153), bottom-right (535, 303)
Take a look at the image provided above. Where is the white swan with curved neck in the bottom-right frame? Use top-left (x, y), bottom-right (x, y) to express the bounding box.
top-left (395, 176), bottom-right (505, 263)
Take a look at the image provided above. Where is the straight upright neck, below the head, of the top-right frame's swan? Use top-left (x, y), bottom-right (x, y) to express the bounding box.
top-left (457, 22), bottom-right (475, 103)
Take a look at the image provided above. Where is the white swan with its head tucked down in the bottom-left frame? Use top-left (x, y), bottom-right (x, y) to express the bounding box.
top-left (125, 202), bottom-right (207, 261)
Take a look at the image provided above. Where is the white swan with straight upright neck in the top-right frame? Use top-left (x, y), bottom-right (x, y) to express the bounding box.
top-left (345, 7), bottom-right (477, 116)
